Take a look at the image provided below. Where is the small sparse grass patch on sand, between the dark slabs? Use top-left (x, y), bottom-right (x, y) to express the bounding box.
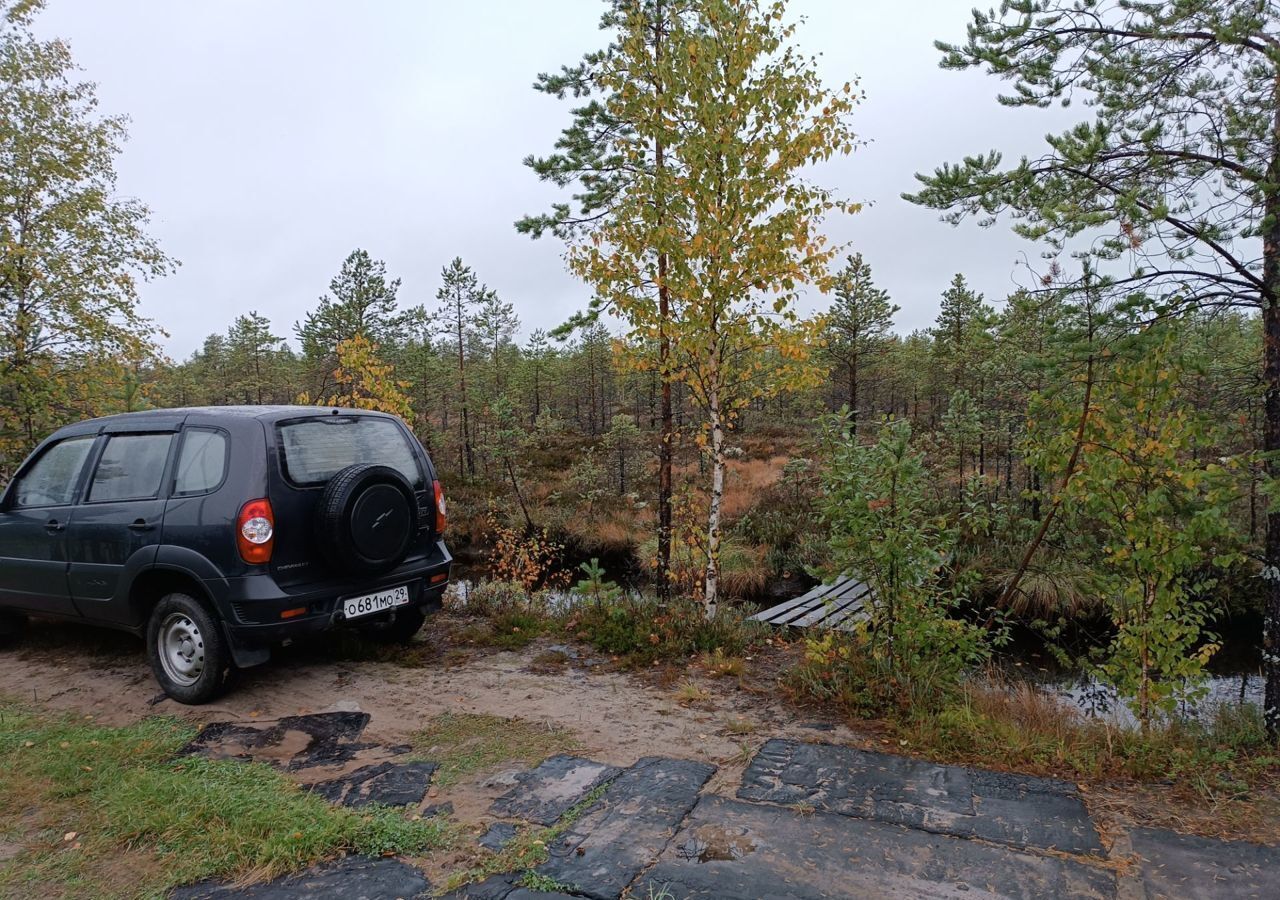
top-left (411, 713), bottom-right (579, 786)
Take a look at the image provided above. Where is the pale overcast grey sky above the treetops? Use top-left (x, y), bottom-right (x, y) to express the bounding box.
top-left (37, 0), bottom-right (1080, 358)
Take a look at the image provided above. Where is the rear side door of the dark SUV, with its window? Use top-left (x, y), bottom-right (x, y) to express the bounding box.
top-left (67, 420), bottom-right (179, 623)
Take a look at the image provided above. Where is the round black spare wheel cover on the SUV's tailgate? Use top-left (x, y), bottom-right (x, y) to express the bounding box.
top-left (316, 463), bottom-right (417, 574)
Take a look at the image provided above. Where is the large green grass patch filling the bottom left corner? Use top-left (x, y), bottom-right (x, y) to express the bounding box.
top-left (0, 705), bottom-right (453, 899)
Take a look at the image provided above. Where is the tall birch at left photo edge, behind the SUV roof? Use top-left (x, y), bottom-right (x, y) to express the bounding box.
top-left (0, 0), bottom-right (174, 480)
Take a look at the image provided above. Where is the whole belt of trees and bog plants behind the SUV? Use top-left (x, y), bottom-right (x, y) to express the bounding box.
top-left (0, 0), bottom-right (1280, 746)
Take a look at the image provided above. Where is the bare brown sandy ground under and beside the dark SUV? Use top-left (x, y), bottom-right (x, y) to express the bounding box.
top-left (0, 616), bottom-right (861, 822)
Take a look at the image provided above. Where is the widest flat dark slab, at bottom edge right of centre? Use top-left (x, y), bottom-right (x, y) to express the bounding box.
top-left (631, 796), bottom-right (1116, 900)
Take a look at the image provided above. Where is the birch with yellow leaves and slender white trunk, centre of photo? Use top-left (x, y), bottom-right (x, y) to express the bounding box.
top-left (568, 0), bottom-right (859, 617)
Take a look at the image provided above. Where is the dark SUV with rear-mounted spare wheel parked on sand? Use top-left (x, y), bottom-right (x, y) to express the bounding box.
top-left (0, 406), bottom-right (452, 703)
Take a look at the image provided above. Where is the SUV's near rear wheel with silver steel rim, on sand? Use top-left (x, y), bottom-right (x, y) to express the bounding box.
top-left (147, 593), bottom-right (232, 705)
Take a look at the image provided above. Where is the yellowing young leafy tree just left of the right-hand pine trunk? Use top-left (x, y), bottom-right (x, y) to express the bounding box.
top-left (1049, 328), bottom-right (1245, 727)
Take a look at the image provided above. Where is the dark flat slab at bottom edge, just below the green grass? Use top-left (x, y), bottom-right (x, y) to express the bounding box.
top-left (170, 856), bottom-right (431, 900)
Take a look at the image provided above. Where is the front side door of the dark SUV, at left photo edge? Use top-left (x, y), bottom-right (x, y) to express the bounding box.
top-left (0, 434), bottom-right (96, 616)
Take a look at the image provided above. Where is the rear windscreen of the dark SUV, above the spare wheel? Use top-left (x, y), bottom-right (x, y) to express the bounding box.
top-left (276, 416), bottom-right (422, 486)
